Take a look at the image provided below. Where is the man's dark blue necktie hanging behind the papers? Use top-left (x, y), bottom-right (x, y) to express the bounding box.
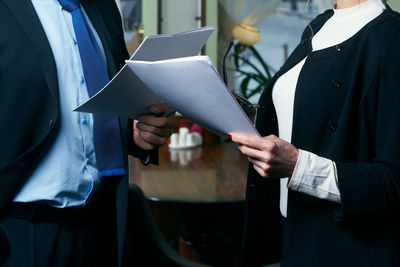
top-left (58, 0), bottom-right (125, 178)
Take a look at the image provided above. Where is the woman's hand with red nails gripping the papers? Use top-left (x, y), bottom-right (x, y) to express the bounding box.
top-left (230, 134), bottom-right (299, 178)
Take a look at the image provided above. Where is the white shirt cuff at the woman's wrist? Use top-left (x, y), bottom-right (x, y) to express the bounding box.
top-left (287, 149), bottom-right (341, 203)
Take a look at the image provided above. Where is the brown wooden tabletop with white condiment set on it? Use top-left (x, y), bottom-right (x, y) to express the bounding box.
top-left (130, 143), bottom-right (248, 203)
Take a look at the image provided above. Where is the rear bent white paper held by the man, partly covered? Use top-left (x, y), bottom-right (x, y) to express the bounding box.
top-left (74, 27), bottom-right (214, 118)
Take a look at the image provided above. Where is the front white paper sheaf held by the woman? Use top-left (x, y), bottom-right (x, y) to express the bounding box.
top-left (127, 56), bottom-right (260, 136)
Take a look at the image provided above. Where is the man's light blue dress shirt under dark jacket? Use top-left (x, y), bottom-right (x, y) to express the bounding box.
top-left (14, 0), bottom-right (106, 208)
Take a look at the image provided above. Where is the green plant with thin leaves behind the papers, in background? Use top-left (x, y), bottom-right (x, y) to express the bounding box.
top-left (232, 43), bottom-right (272, 99)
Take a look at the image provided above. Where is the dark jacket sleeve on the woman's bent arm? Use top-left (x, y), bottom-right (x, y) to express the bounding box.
top-left (336, 27), bottom-right (400, 223)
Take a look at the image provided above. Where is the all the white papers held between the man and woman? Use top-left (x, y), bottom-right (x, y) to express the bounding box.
top-left (75, 27), bottom-right (259, 136)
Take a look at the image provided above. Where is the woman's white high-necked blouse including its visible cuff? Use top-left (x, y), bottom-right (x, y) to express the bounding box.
top-left (272, 0), bottom-right (386, 217)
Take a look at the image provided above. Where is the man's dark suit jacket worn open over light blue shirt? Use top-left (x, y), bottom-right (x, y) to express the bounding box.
top-left (0, 0), bottom-right (147, 262)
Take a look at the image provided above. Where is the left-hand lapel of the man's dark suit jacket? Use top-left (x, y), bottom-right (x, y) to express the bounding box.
top-left (4, 0), bottom-right (59, 105)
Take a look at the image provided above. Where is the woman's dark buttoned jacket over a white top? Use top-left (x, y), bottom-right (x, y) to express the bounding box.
top-left (244, 4), bottom-right (400, 267)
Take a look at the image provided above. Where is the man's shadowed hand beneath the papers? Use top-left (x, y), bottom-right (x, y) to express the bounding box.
top-left (133, 104), bottom-right (175, 150)
